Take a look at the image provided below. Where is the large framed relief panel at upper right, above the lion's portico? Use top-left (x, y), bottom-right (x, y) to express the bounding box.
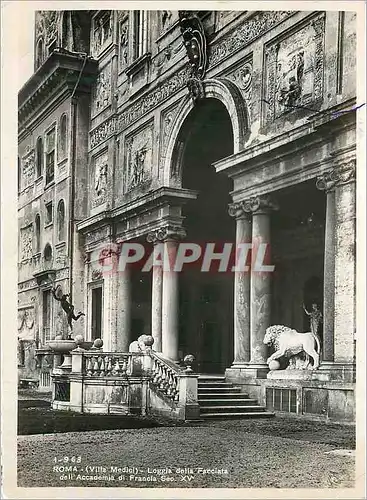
top-left (264, 14), bottom-right (325, 121)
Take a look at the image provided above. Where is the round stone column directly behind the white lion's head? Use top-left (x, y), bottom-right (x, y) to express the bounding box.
top-left (246, 196), bottom-right (276, 368)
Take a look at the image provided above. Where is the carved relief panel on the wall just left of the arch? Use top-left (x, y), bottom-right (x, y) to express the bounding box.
top-left (124, 123), bottom-right (153, 192)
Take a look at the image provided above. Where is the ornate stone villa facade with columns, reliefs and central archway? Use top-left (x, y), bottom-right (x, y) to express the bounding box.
top-left (18, 11), bottom-right (356, 420)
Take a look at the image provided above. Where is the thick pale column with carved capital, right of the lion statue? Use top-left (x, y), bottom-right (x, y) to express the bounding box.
top-left (316, 159), bottom-right (356, 368)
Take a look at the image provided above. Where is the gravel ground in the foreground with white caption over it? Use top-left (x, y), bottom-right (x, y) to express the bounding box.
top-left (18, 419), bottom-right (354, 488)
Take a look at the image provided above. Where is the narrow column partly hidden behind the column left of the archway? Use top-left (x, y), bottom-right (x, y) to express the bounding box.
top-left (147, 232), bottom-right (163, 352)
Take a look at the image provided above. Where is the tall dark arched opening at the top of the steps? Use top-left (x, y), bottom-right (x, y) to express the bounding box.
top-left (177, 98), bottom-right (235, 373)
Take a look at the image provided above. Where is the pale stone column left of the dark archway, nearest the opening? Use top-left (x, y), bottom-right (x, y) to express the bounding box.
top-left (159, 226), bottom-right (185, 361)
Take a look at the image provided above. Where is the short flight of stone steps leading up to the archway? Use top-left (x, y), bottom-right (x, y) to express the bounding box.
top-left (198, 375), bottom-right (274, 419)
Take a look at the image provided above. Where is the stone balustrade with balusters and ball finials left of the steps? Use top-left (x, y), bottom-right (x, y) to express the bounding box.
top-left (52, 339), bottom-right (200, 420)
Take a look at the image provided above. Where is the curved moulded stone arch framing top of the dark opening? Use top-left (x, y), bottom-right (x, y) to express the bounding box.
top-left (164, 78), bottom-right (249, 185)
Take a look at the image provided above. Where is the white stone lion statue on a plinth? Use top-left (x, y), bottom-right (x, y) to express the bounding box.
top-left (263, 325), bottom-right (320, 370)
